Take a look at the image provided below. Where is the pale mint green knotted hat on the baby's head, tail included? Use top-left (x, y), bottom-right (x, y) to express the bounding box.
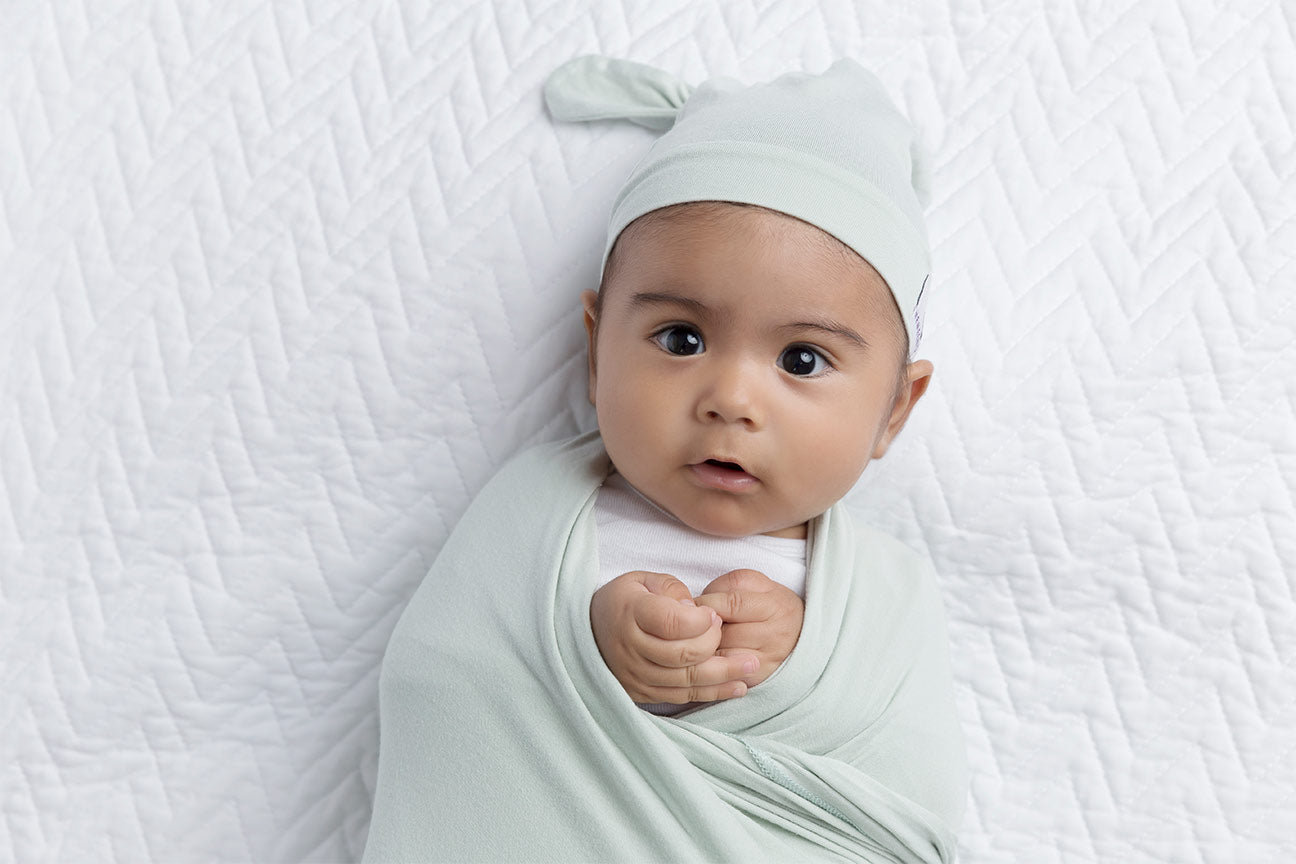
top-left (544, 56), bottom-right (931, 358)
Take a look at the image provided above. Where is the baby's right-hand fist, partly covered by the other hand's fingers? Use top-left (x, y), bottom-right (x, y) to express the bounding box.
top-left (697, 570), bottom-right (806, 687)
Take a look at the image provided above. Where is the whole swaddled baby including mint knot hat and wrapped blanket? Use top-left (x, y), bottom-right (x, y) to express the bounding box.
top-left (365, 57), bottom-right (967, 863)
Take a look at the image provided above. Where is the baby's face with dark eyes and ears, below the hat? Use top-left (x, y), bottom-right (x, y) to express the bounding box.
top-left (583, 206), bottom-right (931, 536)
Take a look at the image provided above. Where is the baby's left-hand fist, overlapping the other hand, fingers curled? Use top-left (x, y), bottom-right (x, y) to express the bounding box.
top-left (590, 570), bottom-right (762, 705)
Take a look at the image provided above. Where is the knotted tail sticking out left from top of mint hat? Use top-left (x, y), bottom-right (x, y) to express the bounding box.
top-left (544, 54), bottom-right (693, 132)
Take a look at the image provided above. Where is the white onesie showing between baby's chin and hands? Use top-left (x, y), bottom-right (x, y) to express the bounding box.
top-left (594, 472), bottom-right (806, 715)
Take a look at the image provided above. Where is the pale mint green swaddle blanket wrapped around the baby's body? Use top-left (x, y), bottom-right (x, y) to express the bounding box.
top-left (365, 433), bottom-right (967, 863)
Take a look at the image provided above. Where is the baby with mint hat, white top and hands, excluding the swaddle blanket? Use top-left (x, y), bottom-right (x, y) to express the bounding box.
top-left (546, 57), bottom-right (932, 714)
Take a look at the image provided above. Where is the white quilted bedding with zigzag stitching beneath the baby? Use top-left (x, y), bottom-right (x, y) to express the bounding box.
top-left (0, 0), bottom-right (1296, 863)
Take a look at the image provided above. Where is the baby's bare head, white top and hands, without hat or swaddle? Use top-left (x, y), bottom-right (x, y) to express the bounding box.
top-left (583, 202), bottom-right (932, 714)
